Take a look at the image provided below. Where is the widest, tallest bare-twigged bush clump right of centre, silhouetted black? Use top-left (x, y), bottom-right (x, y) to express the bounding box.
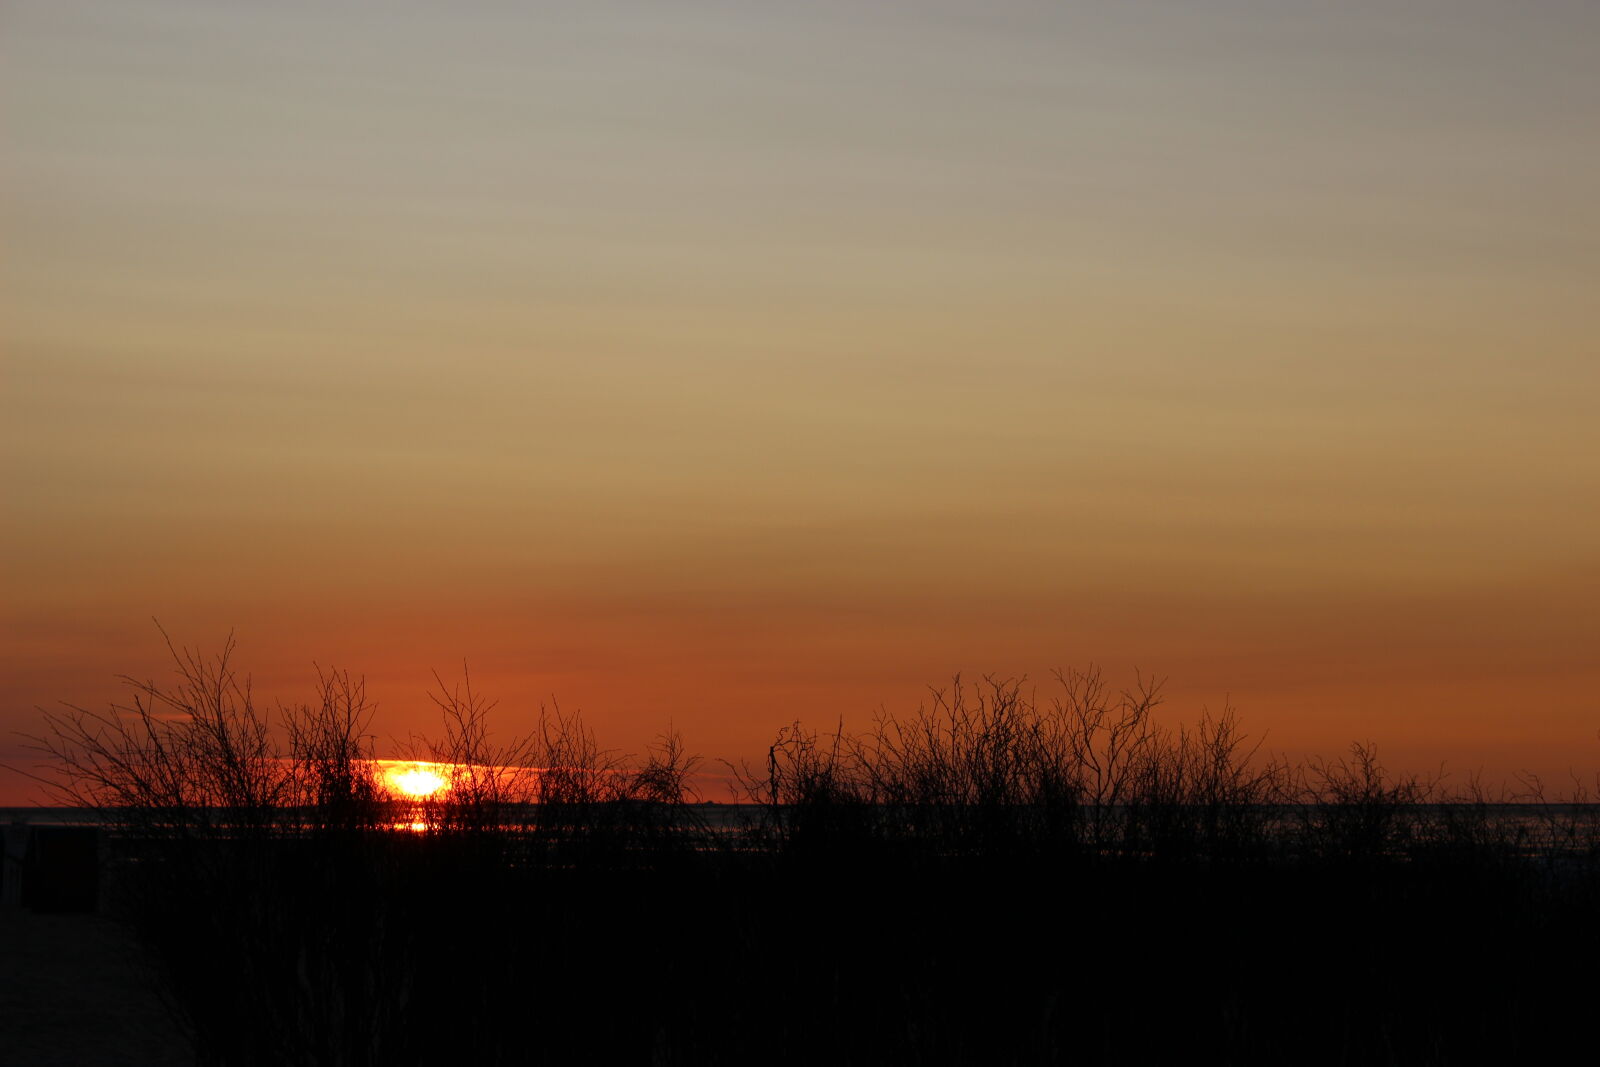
top-left (741, 669), bottom-right (1288, 859)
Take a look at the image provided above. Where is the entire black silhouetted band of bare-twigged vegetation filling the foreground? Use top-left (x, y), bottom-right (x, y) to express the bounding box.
top-left (25, 639), bottom-right (1600, 1067)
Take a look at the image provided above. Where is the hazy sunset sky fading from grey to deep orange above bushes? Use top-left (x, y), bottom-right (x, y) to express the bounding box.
top-left (0, 0), bottom-right (1600, 803)
